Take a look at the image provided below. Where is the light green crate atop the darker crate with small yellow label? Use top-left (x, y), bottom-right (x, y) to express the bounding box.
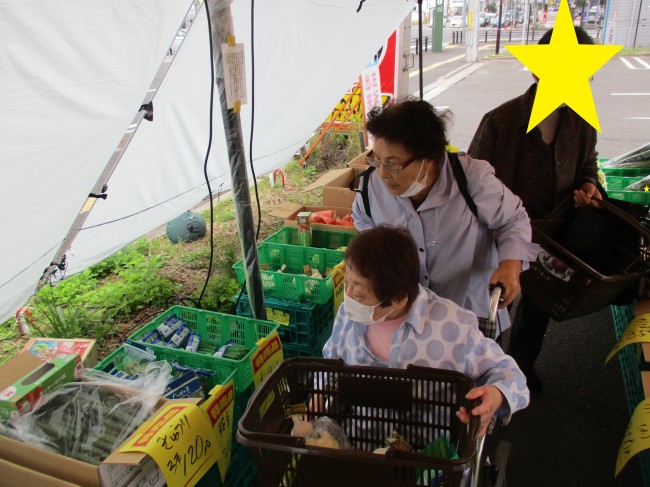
top-left (233, 243), bottom-right (343, 304)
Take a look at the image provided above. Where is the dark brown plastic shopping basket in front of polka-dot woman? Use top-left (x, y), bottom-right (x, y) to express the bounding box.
top-left (237, 357), bottom-right (480, 487)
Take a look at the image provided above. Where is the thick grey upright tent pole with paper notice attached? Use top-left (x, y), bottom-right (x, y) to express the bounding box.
top-left (206, 0), bottom-right (266, 320)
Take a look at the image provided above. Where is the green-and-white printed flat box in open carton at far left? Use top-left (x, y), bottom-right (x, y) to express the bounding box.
top-left (0, 353), bottom-right (83, 419)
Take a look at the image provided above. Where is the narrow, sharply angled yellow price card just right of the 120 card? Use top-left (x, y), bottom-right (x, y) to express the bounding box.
top-left (201, 379), bottom-right (236, 481)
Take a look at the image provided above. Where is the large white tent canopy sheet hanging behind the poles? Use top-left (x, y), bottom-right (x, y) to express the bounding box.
top-left (0, 0), bottom-right (416, 322)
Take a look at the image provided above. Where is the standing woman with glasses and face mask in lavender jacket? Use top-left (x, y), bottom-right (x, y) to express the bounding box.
top-left (352, 99), bottom-right (538, 336)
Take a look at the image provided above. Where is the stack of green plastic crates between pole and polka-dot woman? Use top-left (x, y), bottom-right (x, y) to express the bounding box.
top-left (233, 227), bottom-right (355, 358)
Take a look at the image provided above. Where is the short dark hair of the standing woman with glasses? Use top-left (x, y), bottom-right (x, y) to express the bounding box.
top-left (366, 97), bottom-right (449, 160)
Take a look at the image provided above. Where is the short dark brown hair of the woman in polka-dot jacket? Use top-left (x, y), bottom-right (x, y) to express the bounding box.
top-left (345, 225), bottom-right (420, 305)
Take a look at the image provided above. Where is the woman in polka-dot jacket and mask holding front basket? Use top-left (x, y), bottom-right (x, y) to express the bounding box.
top-left (323, 226), bottom-right (530, 433)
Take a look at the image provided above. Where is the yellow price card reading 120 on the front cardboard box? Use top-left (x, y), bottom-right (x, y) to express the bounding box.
top-left (120, 403), bottom-right (220, 487)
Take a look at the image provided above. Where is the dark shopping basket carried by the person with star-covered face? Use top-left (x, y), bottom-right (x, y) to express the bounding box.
top-left (521, 196), bottom-right (650, 321)
